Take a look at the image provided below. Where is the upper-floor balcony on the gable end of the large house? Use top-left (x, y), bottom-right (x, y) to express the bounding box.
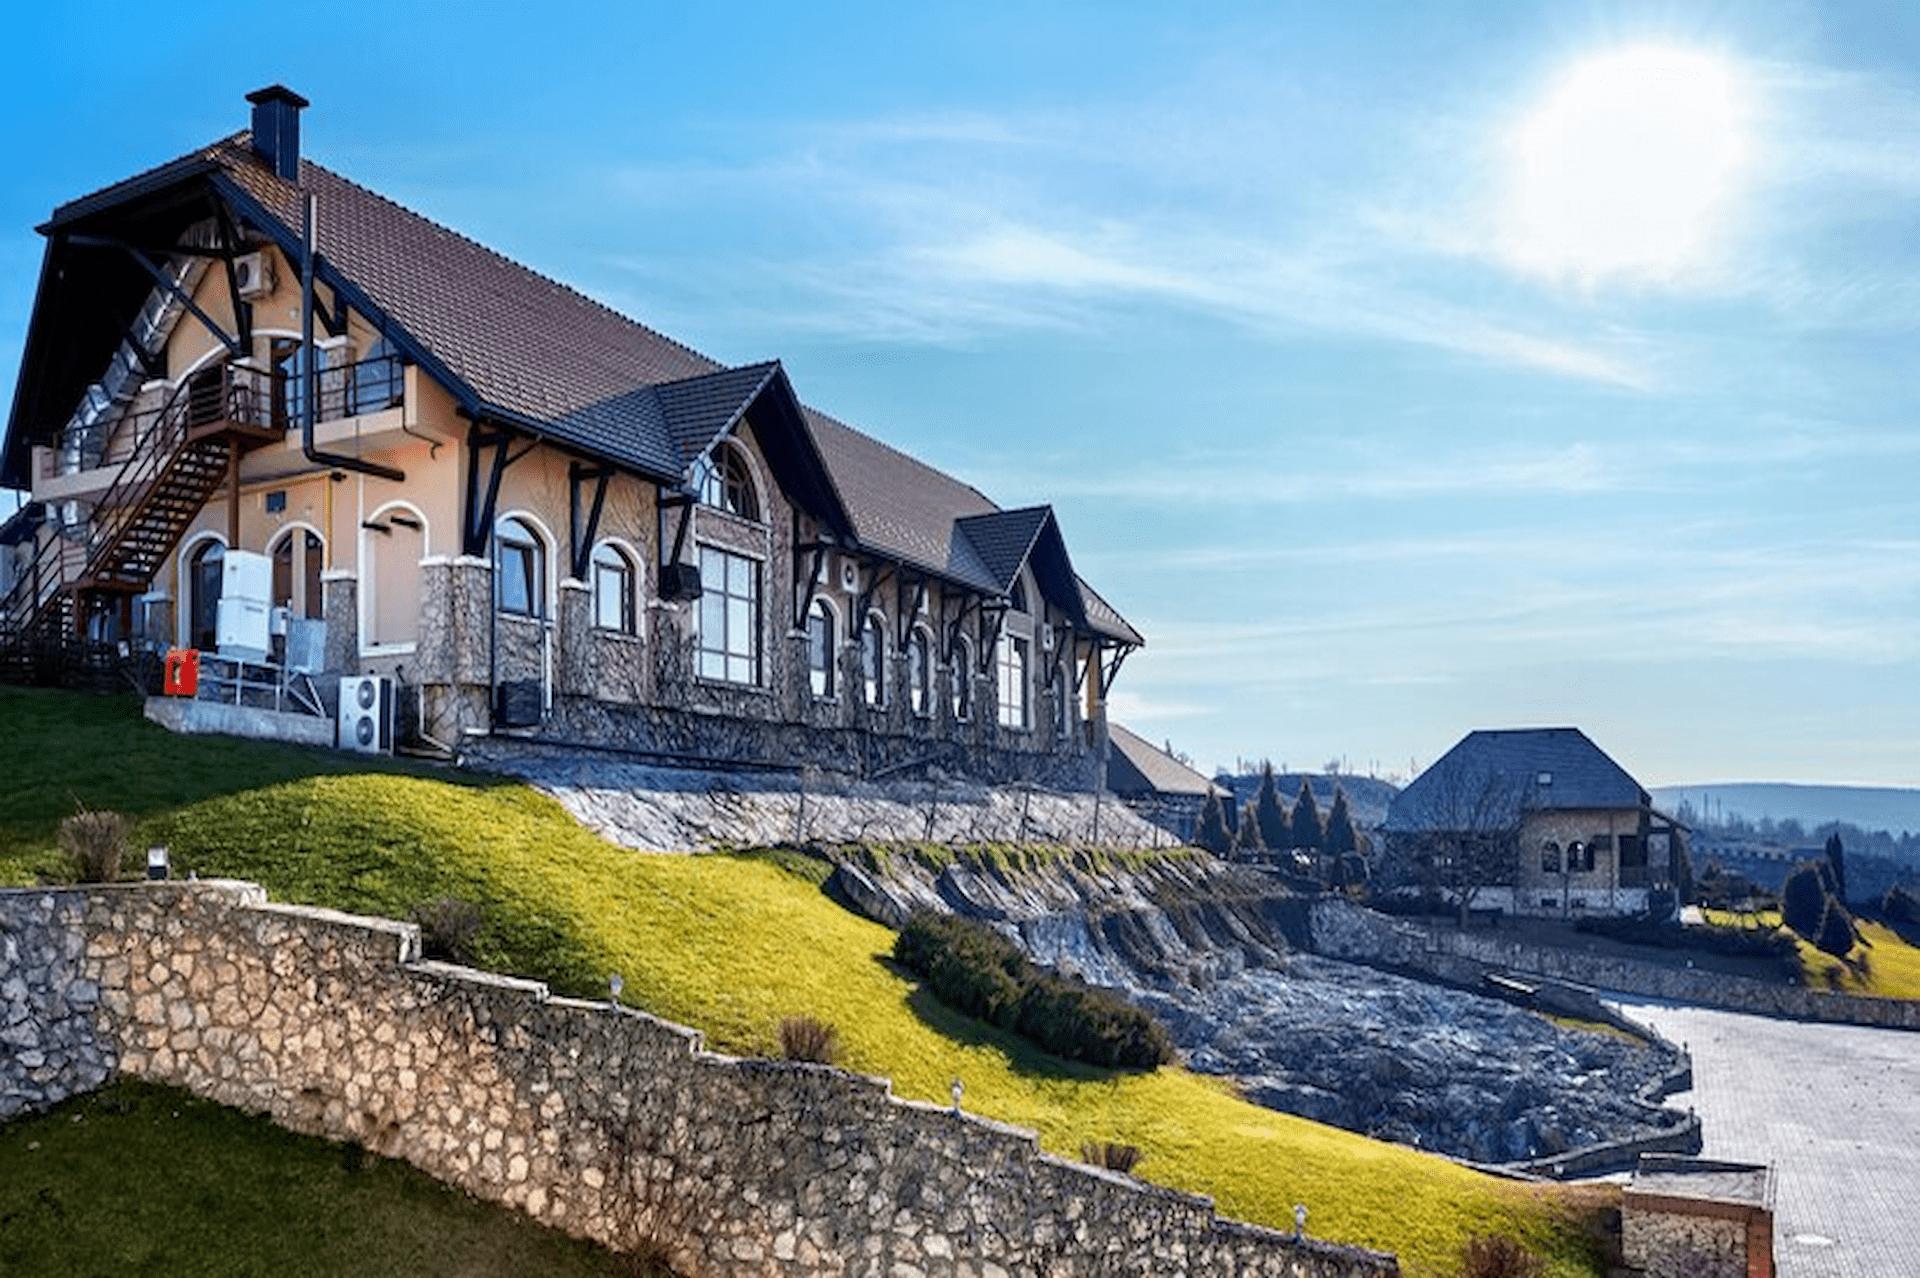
top-left (33, 355), bottom-right (405, 501)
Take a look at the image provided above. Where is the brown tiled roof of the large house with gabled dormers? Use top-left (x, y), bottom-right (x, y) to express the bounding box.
top-left (11, 132), bottom-right (1142, 645)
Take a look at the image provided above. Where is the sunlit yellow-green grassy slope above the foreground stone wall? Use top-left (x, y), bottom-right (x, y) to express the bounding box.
top-left (0, 691), bottom-right (1601, 1274)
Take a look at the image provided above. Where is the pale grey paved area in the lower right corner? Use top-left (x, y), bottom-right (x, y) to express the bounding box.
top-left (1611, 994), bottom-right (1920, 1278)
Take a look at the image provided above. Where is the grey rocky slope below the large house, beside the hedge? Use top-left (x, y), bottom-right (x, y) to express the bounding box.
top-left (828, 854), bottom-right (1680, 1163)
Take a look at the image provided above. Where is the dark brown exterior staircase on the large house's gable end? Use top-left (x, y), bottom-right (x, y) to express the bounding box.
top-left (0, 365), bottom-right (282, 683)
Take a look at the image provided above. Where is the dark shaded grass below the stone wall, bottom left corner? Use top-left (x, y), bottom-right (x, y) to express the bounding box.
top-left (0, 1080), bottom-right (634, 1278)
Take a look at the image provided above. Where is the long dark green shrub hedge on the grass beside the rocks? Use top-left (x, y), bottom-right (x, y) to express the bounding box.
top-left (893, 911), bottom-right (1173, 1069)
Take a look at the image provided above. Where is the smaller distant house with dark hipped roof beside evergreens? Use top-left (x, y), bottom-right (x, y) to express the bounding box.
top-left (1382, 727), bottom-right (1686, 917)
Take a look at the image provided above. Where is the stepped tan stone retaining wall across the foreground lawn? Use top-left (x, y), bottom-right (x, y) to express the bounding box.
top-left (0, 883), bottom-right (1398, 1278)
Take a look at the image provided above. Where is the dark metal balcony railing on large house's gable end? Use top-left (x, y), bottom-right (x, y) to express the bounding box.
top-left (35, 355), bottom-right (405, 480)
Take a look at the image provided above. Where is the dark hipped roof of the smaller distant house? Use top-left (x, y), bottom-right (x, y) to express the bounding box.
top-left (1382, 727), bottom-right (1651, 833)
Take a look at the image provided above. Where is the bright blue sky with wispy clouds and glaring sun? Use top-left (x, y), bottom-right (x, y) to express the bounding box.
top-left (0, 2), bottom-right (1920, 785)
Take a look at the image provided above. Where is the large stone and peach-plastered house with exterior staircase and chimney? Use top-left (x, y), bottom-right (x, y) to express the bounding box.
top-left (0, 86), bottom-right (1142, 787)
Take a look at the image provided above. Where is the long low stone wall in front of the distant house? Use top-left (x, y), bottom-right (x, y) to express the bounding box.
top-left (1313, 900), bottom-right (1920, 1030)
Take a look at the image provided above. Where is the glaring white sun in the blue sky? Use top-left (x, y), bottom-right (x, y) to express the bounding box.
top-left (1505, 46), bottom-right (1749, 284)
